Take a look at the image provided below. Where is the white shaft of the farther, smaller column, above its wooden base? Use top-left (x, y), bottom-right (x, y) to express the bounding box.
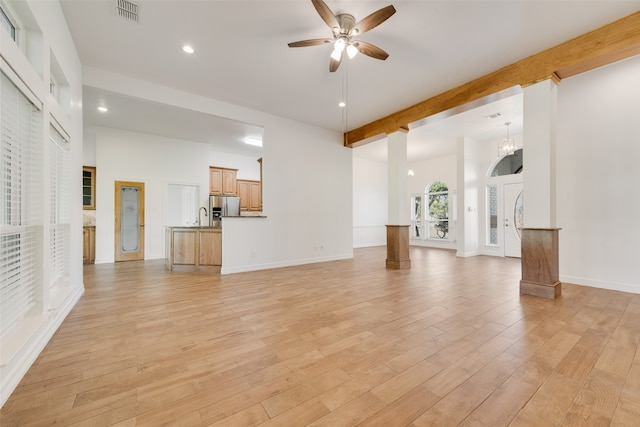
top-left (387, 131), bottom-right (410, 225)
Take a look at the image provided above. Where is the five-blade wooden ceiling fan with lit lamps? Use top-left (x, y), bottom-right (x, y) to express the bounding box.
top-left (289, 0), bottom-right (396, 72)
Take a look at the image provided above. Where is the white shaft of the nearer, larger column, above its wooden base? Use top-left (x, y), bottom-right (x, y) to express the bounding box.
top-left (522, 80), bottom-right (557, 228)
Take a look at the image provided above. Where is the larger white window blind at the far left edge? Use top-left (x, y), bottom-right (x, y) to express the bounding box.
top-left (0, 72), bottom-right (43, 338)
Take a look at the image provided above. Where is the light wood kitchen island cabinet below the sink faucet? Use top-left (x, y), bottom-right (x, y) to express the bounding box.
top-left (164, 227), bottom-right (222, 272)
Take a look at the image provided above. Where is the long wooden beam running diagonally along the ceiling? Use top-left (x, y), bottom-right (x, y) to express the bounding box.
top-left (344, 12), bottom-right (640, 148)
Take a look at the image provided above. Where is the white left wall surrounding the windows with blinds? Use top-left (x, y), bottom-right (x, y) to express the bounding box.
top-left (0, 1), bottom-right (84, 405)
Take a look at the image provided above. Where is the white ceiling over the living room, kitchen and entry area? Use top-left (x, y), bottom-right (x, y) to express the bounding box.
top-left (61, 0), bottom-right (640, 162)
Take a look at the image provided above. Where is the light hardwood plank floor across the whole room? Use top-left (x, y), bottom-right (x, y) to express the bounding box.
top-left (0, 248), bottom-right (640, 427)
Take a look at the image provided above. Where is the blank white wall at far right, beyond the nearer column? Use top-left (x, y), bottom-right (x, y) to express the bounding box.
top-left (556, 57), bottom-right (640, 293)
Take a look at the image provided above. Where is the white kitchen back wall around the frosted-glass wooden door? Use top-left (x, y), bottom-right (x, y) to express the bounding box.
top-left (94, 128), bottom-right (215, 264)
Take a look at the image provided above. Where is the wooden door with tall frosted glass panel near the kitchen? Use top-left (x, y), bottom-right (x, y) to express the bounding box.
top-left (114, 181), bottom-right (144, 261)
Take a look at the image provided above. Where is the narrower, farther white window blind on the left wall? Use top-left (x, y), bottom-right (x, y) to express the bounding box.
top-left (49, 125), bottom-right (71, 286)
